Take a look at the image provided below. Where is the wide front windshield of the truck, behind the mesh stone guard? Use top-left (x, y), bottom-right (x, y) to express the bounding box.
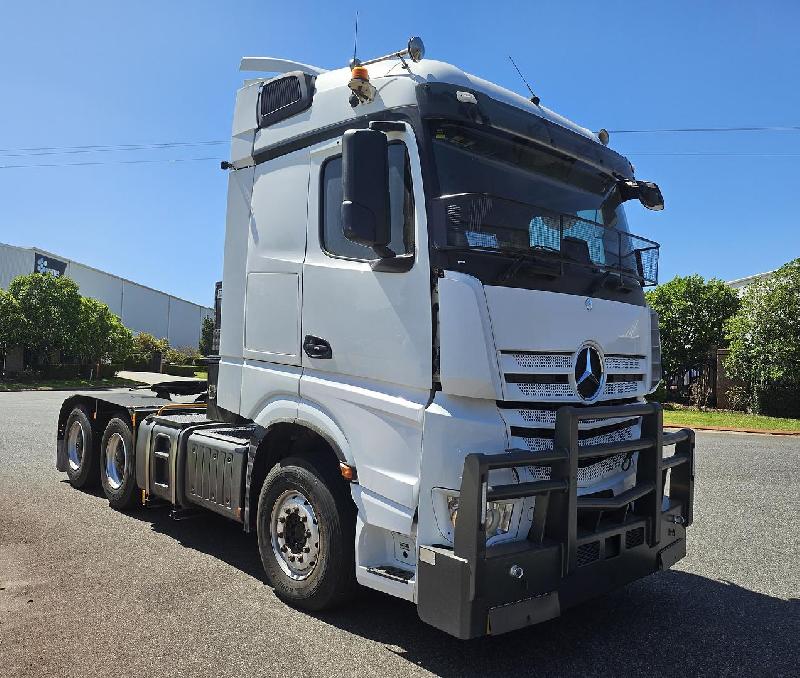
top-left (431, 122), bottom-right (658, 284)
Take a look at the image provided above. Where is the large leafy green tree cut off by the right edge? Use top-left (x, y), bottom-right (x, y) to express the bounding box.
top-left (725, 259), bottom-right (800, 409)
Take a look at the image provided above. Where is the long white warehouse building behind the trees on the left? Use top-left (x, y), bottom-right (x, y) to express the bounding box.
top-left (0, 243), bottom-right (214, 347)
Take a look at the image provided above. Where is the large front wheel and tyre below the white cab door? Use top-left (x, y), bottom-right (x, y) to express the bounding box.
top-left (256, 455), bottom-right (356, 612)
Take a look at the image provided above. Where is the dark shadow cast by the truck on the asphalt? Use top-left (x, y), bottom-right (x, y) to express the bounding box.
top-left (123, 508), bottom-right (800, 677)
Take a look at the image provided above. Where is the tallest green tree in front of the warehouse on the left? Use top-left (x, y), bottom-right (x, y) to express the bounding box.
top-left (8, 273), bottom-right (81, 363)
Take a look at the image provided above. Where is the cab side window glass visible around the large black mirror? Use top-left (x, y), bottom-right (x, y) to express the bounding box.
top-left (320, 143), bottom-right (414, 261)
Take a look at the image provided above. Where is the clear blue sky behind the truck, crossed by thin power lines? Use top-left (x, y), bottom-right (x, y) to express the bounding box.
top-left (0, 0), bottom-right (800, 304)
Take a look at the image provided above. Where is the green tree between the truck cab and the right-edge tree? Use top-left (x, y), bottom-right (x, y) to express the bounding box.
top-left (646, 274), bottom-right (739, 390)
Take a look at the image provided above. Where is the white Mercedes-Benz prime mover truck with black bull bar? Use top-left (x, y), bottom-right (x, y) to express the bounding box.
top-left (57, 38), bottom-right (694, 638)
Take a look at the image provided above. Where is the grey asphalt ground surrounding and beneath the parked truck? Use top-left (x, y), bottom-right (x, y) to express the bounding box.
top-left (0, 392), bottom-right (800, 678)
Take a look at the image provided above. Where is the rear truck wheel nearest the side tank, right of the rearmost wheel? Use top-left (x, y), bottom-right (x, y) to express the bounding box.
top-left (100, 417), bottom-right (141, 511)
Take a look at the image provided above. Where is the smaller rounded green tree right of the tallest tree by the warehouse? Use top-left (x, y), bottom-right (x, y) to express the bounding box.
top-left (73, 297), bottom-right (133, 364)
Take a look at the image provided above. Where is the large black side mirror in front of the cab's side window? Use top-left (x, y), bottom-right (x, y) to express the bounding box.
top-left (342, 129), bottom-right (393, 257)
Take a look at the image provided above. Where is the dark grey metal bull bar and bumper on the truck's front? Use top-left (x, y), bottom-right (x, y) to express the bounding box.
top-left (417, 403), bottom-right (694, 638)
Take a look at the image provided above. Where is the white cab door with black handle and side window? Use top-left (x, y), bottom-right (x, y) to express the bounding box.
top-left (300, 125), bottom-right (432, 507)
